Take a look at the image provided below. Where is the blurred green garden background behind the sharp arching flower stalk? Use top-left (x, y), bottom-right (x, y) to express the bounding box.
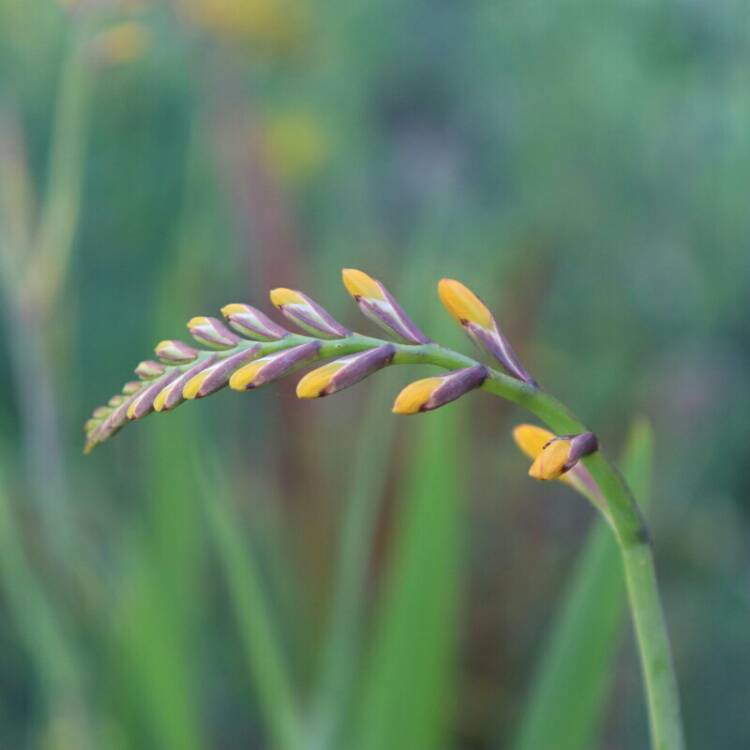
top-left (0, 0), bottom-right (750, 750)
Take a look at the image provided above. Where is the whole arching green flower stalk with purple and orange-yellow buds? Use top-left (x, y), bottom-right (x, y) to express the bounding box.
top-left (84, 269), bottom-right (684, 750)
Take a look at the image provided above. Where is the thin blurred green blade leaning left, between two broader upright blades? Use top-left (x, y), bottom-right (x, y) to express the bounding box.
top-left (202, 462), bottom-right (301, 750)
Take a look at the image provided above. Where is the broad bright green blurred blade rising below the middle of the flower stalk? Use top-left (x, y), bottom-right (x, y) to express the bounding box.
top-left (356, 405), bottom-right (465, 750)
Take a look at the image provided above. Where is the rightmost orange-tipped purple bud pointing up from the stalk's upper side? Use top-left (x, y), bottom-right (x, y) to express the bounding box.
top-left (438, 279), bottom-right (536, 385)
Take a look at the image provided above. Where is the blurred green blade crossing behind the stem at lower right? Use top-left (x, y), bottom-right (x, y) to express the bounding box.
top-left (514, 420), bottom-right (653, 750)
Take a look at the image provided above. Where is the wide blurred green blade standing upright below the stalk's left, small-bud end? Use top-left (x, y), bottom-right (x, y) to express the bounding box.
top-left (113, 420), bottom-right (204, 750)
